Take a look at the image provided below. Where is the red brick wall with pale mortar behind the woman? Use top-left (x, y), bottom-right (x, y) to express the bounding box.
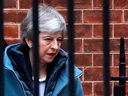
top-left (4, 0), bottom-right (128, 96)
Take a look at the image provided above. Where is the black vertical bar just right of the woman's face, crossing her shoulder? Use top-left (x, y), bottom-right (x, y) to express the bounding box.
top-left (68, 0), bottom-right (75, 96)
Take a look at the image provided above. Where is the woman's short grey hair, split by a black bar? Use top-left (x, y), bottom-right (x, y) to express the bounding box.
top-left (21, 4), bottom-right (67, 43)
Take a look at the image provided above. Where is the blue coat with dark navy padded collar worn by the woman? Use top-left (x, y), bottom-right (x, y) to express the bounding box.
top-left (4, 44), bottom-right (84, 96)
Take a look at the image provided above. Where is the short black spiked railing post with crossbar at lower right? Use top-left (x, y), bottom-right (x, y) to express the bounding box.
top-left (111, 38), bottom-right (128, 96)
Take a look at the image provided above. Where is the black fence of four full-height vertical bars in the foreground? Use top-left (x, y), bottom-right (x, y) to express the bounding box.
top-left (0, 0), bottom-right (118, 96)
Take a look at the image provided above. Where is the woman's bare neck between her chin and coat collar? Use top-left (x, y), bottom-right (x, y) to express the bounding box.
top-left (29, 49), bottom-right (47, 78)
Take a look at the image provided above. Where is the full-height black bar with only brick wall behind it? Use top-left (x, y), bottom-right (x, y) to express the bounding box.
top-left (103, 0), bottom-right (110, 96)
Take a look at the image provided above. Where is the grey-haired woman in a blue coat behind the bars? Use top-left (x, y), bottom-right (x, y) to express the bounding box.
top-left (4, 4), bottom-right (83, 96)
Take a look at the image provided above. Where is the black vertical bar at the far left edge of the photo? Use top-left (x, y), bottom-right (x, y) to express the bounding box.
top-left (0, 0), bottom-right (4, 96)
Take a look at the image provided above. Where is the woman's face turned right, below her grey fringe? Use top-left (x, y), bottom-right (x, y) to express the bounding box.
top-left (39, 32), bottom-right (63, 64)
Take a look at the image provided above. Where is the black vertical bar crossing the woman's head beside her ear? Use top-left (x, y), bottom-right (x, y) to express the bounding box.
top-left (33, 0), bottom-right (39, 96)
